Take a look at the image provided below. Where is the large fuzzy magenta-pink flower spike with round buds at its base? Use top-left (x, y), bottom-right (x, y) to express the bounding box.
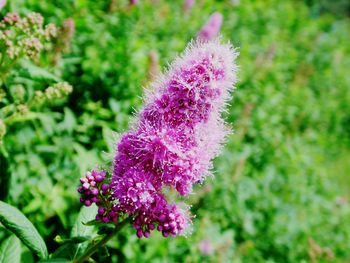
top-left (79, 40), bottom-right (236, 237)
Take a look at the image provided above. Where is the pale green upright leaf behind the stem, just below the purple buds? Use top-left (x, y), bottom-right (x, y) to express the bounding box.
top-left (71, 206), bottom-right (97, 259)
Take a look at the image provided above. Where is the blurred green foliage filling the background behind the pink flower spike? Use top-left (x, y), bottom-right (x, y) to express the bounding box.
top-left (0, 0), bottom-right (350, 262)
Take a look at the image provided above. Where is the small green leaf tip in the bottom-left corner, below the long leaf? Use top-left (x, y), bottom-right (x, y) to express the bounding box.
top-left (0, 235), bottom-right (21, 263)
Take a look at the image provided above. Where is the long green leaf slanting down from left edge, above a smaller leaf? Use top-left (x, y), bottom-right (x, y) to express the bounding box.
top-left (0, 201), bottom-right (48, 258)
